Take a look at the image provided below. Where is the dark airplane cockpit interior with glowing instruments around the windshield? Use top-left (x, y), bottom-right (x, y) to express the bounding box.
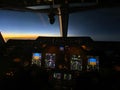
top-left (0, 0), bottom-right (120, 90)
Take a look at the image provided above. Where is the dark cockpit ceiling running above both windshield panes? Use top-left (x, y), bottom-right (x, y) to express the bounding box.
top-left (0, 0), bottom-right (120, 10)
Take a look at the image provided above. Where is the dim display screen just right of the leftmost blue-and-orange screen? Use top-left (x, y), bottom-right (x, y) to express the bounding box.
top-left (45, 53), bottom-right (56, 68)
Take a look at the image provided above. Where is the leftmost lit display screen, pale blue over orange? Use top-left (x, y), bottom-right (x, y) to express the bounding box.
top-left (32, 52), bottom-right (42, 66)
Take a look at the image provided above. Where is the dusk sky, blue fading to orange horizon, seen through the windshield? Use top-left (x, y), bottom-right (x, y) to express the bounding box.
top-left (0, 8), bottom-right (120, 41)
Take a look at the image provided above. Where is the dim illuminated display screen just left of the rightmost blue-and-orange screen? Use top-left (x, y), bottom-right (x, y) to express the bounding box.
top-left (70, 55), bottom-right (82, 71)
